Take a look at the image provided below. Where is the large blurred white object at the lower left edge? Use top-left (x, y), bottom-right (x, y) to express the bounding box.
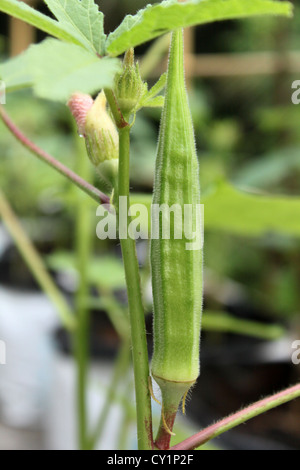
top-left (0, 286), bottom-right (59, 427)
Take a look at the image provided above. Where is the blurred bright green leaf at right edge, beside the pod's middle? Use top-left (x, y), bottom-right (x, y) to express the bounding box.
top-left (202, 182), bottom-right (300, 237)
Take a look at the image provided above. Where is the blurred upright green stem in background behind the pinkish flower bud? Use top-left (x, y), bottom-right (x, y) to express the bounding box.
top-left (73, 131), bottom-right (92, 450)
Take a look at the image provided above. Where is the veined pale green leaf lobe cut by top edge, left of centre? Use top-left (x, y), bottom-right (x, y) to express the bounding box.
top-left (44, 0), bottom-right (106, 55)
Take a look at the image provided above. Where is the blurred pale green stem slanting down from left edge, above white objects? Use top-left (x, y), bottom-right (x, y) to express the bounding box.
top-left (0, 190), bottom-right (76, 330)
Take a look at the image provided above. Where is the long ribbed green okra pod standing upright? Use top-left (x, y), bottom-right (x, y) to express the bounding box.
top-left (151, 30), bottom-right (202, 440)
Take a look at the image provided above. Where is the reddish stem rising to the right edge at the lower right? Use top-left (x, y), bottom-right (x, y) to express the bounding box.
top-left (171, 384), bottom-right (300, 450)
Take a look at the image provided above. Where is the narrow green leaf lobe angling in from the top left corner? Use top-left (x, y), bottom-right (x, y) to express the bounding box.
top-left (0, 0), bottom-right (85, 44)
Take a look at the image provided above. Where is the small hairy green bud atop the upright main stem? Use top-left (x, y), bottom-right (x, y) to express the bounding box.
top-left (115, 49), bottom-right (147, 115)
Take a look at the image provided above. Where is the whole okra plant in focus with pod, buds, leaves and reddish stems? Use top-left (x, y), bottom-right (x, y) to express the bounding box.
top-left (0, 0), bottom-right (300, 450)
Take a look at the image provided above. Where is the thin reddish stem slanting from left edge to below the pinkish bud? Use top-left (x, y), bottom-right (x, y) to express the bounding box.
top-left (0, 106), bottom-right (110, 204)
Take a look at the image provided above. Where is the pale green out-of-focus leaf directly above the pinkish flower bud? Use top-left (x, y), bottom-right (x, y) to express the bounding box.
top-left (26, 38), bottom-right (120, 102)
